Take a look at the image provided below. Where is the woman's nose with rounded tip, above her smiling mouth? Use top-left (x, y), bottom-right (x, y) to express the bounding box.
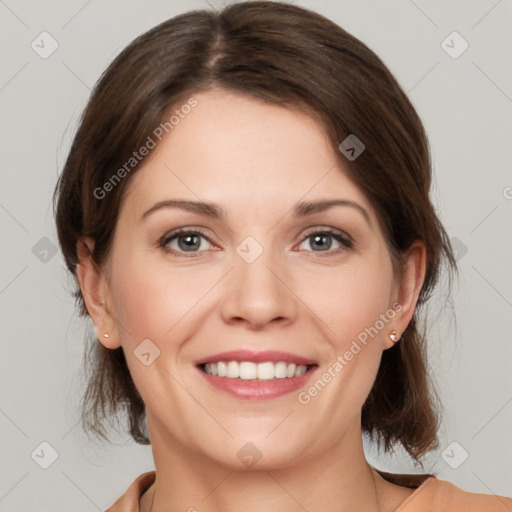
top-left (221, 242), bottom-right (298, 330)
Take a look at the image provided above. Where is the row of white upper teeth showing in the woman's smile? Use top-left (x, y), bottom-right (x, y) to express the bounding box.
top-left (204, 361), bottom-right (308, 380)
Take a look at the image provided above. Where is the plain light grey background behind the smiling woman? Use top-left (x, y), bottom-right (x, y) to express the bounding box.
top-left (0, 0), bottom-right (512, 512)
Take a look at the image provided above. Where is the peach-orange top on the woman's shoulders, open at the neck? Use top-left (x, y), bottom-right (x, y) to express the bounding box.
top-left (105, 468), bottom-right (512, 512)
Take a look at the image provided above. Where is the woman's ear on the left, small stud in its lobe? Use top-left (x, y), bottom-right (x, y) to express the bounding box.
top-left (76, 237), bottom-right (121, 349)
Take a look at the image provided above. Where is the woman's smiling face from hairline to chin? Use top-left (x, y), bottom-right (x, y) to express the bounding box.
top-left (82, 91), bottom-right (422, 468)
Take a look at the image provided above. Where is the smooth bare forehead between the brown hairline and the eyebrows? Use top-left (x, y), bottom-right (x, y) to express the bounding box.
top-left (121, 90), bottom-right (371, 220)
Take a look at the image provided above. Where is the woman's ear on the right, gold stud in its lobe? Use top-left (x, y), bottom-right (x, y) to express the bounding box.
top-left (384, 240), bottom-right (427, 349)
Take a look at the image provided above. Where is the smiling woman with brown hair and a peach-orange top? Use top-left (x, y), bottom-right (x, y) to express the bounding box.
top-left (55, 2), bottom-right (512, 512)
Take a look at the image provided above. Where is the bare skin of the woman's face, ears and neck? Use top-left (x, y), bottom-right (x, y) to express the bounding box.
top-left (78, 90), bottom-right (425, 512)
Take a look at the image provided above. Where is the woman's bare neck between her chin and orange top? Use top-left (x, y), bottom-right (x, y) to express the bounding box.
top-left (140, 420), bottom-right (393, 512)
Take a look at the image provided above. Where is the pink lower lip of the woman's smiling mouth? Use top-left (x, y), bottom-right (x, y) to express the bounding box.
top-left (198, 366), bottom-right (317, 400)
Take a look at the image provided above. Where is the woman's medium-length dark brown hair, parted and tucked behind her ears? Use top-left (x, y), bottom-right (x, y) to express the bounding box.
top-left (54, 1), bottom-right (456, 460)
